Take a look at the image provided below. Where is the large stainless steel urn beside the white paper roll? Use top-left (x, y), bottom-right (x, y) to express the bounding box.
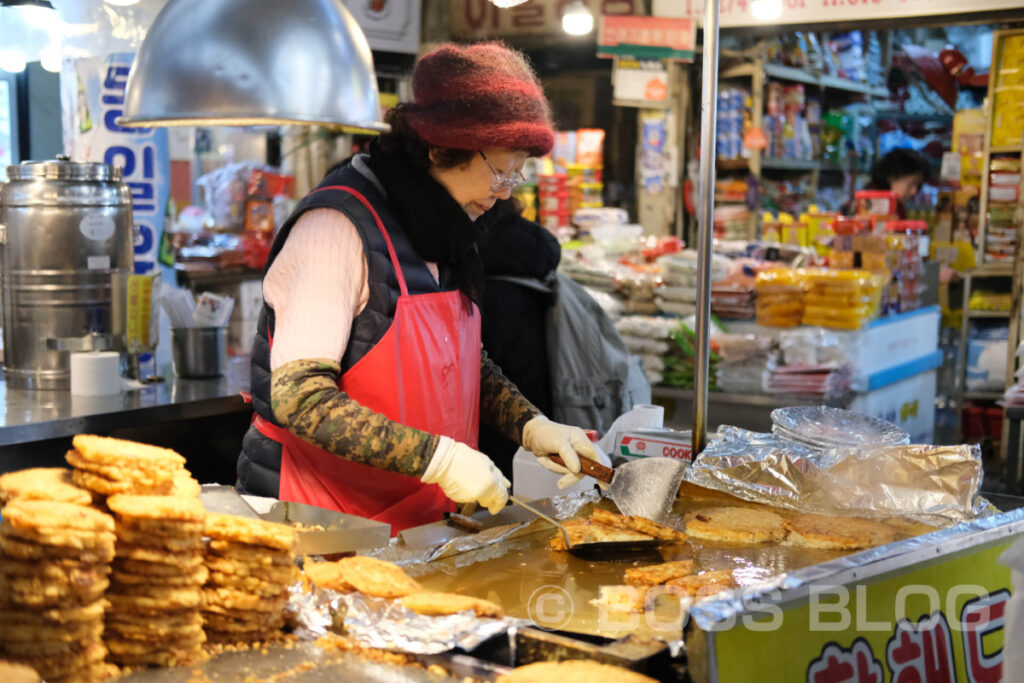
top-left (0, 157), bottom-right (134, 389)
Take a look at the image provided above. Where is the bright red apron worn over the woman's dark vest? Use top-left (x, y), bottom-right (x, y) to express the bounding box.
top-left (255, 185), bottom-right (480, 535)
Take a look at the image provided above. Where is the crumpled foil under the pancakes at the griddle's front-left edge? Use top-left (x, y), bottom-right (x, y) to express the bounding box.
top-left (285, 583), bottom-right (530, 654)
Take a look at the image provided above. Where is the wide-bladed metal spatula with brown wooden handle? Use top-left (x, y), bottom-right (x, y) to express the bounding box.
top-left (550, 456), bottom-right (686, 522)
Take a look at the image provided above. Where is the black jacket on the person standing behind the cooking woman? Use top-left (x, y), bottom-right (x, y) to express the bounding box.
top-left (477, 200), bottom-right (561, 479)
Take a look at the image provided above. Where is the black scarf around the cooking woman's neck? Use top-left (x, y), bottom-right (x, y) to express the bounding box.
top-left (370, 140), bottom-right (485, 305)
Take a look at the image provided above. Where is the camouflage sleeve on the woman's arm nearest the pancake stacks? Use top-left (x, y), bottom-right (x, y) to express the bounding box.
top-left (270, 358), bottom-right (438, 477)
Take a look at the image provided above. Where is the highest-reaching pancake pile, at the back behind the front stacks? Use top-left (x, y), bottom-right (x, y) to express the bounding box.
top-left (65, 434), bottom-right (191, 496)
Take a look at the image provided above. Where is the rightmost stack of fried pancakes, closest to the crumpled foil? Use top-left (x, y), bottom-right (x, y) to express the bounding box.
top-left (203, 514), bottom-right (297, 643)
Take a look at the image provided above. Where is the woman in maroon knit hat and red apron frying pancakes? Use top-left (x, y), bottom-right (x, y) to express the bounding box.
top-left (238, 43), bottom-right (597, 533)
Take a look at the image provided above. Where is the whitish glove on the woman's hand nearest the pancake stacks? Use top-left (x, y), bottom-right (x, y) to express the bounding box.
top-left (420, 436), bottom-right (512, 515)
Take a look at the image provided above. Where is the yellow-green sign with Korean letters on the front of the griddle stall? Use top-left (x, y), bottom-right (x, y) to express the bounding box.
top-left (714, 538), bottom-right (1016, 683)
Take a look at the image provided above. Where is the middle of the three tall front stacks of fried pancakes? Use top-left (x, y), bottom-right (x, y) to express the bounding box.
top-left (103, 494), bottom-right (207, 667)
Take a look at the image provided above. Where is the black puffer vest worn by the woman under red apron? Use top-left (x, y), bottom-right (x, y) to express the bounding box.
top-left (236, 158), bottom-right (457, 498)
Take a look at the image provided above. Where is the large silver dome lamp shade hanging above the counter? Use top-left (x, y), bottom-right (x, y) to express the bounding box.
top-left (117, 0), bottom-right (388, 131)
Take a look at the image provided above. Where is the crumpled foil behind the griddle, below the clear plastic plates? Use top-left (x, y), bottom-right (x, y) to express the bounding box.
top-left (684, 427), bottom-right (992, 526)
